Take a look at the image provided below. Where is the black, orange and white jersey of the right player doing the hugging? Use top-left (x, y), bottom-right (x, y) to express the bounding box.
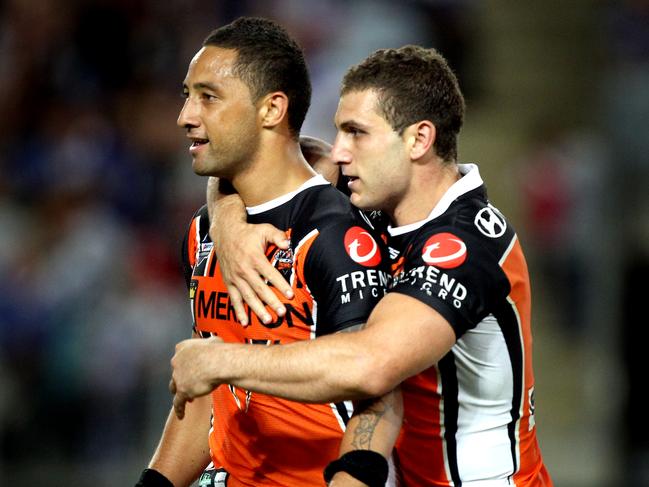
top-left (389, 165), bottom-right (552, 487)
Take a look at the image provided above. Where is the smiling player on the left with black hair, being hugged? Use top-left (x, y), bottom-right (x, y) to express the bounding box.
top-left (138, 18), bottom-right (389, 487)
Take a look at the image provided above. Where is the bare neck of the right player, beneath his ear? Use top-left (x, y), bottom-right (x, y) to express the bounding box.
top-left (388, 158), bottom-right (461, 227)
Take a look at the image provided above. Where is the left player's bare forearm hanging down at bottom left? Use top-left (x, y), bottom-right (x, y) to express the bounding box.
top-left (149, 396), bottom-right (211, 487)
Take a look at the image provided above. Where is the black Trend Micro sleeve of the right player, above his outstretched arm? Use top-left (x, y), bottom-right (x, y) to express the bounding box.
top-left (390, 227), bottom-right (509, 338)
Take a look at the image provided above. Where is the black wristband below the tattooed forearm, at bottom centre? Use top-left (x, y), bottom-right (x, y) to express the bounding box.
top-left (324, 450), bottom-right (390, 487)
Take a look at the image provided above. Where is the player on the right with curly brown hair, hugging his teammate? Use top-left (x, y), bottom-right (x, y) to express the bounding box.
top-left (172, 46), bottom-right (552, 487)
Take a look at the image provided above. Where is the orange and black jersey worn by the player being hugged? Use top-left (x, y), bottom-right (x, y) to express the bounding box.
top-left (183, 176), bottom-right (389, 487)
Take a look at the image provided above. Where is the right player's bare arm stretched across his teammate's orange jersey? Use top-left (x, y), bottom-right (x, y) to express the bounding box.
top-left (172, 293), bottom-right (455, 412)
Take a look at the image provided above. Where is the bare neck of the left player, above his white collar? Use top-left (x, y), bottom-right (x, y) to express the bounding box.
top-left (232, 132), bottom-right (316, 206)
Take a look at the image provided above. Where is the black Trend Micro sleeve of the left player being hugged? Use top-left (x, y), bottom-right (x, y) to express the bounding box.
top-left (304, 219), bottom-right (389, 336)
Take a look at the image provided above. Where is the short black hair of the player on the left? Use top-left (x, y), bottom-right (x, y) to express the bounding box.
top-left (203, 17), bottom-right (311, 138)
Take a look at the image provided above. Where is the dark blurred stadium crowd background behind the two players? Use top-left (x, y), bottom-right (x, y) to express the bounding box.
top-left (0, 0), bottom-right (649, 487)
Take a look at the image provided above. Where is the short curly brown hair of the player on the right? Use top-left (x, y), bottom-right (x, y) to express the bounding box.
top-left (340, 45), bottom-right (465, 161)
